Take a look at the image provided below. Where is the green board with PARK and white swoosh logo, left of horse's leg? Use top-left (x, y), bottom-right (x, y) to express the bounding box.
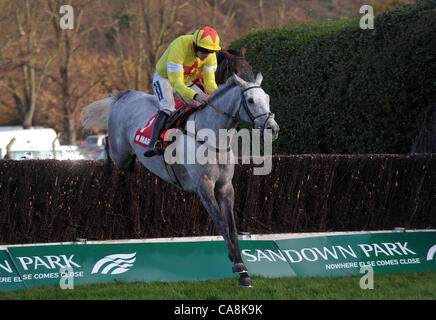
top-left (4, 241), bottom-right (234, 287)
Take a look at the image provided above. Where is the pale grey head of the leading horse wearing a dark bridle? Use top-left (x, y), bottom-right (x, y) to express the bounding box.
top-left (233, 73), bottom-right (280, 140)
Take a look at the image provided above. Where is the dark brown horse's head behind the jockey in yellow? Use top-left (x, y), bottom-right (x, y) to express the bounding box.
top-left (215, 48), bottom-right (254, 85)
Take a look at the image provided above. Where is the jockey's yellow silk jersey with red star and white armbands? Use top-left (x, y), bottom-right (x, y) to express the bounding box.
top-left (156, 35), bottom-right (218, 100)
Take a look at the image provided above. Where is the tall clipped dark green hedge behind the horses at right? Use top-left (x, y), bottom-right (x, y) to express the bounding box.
top-left (231, 0), bottom-right (436, 154)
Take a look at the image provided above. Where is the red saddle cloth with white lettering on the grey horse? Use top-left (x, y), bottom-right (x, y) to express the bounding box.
top-left (133, 99), bottom-right (198, 147)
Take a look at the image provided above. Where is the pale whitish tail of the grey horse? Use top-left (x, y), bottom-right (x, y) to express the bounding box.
top-left (80, 97), bottom-right (113, 130)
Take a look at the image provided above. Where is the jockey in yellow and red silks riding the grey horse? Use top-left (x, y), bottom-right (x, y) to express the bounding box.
top-left (144, 27), bottom-right (221, 157)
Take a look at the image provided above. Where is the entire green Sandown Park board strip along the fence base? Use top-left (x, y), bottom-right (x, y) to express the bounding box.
top-left (0, 231), bottom-right (436, 290)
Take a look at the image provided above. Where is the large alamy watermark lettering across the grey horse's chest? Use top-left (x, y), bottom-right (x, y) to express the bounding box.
top-left (164, 121), bottom-right (273, 175)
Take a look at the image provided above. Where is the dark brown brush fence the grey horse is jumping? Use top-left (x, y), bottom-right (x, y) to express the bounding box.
top-left (0, 155), bottom-right (436, 244)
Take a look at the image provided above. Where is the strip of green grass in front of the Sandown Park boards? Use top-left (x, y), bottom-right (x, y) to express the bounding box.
top-left (0, 272), bottom-right (436, 300)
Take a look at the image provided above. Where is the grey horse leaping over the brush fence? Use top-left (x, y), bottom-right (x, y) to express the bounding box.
top-left (82, 73), bottom-right (279, 287)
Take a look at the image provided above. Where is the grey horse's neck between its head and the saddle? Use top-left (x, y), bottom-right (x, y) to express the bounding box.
top-left (194, 87), bottom-right (241, 137)
